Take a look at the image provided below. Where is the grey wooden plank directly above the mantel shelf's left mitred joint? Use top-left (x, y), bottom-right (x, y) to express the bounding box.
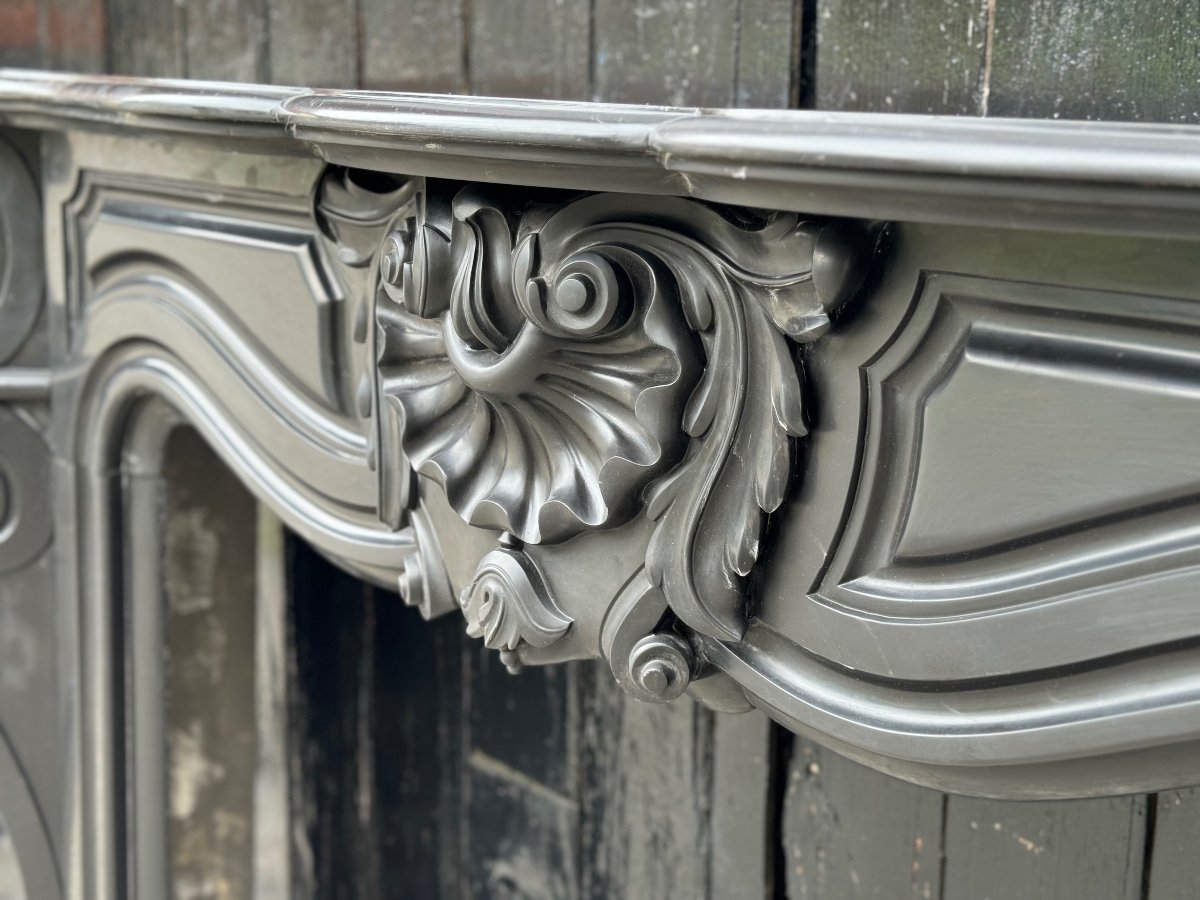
top-left (266, 0), bottom-right (359, 88)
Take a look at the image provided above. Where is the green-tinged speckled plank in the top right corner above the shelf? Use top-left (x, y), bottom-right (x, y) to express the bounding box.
top-left (986, 0), bottom-right (1200, 122)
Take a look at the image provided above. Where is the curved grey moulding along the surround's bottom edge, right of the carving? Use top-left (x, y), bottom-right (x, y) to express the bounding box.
top-left (702, 626), bottom-right (1200, 799)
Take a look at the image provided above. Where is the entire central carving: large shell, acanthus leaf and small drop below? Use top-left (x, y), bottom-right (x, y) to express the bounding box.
top-left (364, 186), bottom-right (874, 664)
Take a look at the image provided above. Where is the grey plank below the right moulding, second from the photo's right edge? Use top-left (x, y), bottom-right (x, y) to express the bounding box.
top-left (944, 797), bottom-right (1146, 900)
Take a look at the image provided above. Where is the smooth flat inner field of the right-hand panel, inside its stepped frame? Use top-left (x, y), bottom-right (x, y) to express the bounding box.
top-left (895, 303), bottom-right (1200, 563)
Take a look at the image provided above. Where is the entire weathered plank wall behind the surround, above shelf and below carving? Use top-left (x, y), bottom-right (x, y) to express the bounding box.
top-left (7, 0), bottom-right (1200, 900)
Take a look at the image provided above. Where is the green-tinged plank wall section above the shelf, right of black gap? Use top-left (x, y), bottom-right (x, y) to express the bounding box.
top-left (815, 0), bottom-right (1200, 122)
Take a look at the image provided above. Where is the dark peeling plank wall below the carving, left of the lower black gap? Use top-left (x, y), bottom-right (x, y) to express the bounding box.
top-left (289, 541), bottom-right (772, 900)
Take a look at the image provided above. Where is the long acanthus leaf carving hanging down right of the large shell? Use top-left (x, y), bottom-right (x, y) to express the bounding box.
top-left (646, 214), bottom-right (864, 640)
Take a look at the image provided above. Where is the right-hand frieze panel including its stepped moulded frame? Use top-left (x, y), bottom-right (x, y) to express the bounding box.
top-left (787, 272), bottom-right (1200, 682)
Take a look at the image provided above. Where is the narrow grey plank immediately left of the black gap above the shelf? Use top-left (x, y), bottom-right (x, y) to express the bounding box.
top-left (733, 0), bottom-right (802, 109)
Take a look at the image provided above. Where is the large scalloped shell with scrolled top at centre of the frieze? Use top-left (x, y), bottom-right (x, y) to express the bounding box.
top-left (377, 184), bottom-right (697, 544)
